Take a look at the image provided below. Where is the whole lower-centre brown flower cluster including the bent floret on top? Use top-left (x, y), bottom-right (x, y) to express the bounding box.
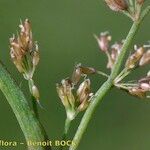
top-left (56, 64), bottom-right (95, 120)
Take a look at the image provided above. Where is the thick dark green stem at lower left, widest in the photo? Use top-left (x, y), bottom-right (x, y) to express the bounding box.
top-left (0, 61), bottom-right (51, 150)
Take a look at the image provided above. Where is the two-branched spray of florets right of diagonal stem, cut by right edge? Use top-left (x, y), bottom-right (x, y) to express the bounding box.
top-left (114, 45), bottom-right (150, 98)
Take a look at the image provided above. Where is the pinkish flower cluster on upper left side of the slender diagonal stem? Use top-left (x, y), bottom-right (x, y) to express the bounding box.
top-left (95, 32), bottom-right (123, 69)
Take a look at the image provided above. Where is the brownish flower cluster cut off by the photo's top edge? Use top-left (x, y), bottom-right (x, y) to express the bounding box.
top-left (105, 0), bottom-right (144, 20)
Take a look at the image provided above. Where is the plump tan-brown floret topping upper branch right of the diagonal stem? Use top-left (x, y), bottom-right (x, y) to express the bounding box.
top-left (125, 47), bottom-right (144, 69)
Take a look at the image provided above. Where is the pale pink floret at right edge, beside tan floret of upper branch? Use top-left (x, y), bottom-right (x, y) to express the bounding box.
top-left (139, 49), bottom-right (150, 66)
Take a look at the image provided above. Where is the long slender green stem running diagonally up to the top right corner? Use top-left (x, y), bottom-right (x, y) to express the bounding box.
top-left (69, 7), bottom-right (150, 150)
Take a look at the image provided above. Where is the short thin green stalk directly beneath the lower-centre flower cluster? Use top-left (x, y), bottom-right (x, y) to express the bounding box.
top-left (59, 118), bottom-right (72, 150)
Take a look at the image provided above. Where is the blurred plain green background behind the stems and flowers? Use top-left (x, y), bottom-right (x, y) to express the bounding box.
top-left (0, 0), bottom-right (150, 150)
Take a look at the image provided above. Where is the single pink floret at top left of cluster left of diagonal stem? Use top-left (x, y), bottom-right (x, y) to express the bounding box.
top-left (95, 32), bottom-right (111, 52)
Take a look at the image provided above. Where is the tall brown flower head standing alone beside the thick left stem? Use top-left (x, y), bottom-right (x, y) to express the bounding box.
top-left (10, 19), bottom-right (39, 80)
